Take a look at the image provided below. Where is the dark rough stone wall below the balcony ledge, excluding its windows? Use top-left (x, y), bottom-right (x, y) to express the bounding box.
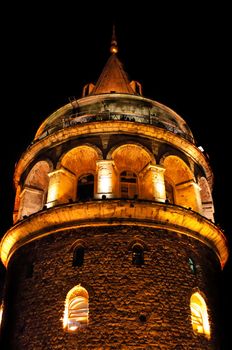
top-left (1, 226), bottom-right (220, 350)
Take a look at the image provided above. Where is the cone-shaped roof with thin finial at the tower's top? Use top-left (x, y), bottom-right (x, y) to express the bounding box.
top-left (91, 25), bottom-right (135, 95)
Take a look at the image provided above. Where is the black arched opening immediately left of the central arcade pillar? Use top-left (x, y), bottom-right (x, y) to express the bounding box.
top-left (77, 174), bottom-right (94, 201)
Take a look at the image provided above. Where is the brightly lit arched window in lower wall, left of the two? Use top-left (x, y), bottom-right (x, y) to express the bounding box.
top-left (63, 285), bottom-right (89, 332)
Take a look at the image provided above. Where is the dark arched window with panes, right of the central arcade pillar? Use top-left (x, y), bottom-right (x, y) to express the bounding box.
top-left (120, 171), bottom-right (138, 198)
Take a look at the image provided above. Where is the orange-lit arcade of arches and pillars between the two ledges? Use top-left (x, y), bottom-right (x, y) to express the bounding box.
top-left (12, 130), bottom-right (213, 221)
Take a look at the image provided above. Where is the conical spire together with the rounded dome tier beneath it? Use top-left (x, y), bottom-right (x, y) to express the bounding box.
top-left (34, 31), bottom-right (195, 144)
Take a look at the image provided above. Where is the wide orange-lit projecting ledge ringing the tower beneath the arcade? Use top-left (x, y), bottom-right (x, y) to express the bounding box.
top-left (0, 199), bottom-right (228, 267)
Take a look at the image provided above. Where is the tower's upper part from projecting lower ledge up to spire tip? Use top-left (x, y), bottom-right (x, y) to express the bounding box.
top-left (2, 27), bottom-right (228, 266)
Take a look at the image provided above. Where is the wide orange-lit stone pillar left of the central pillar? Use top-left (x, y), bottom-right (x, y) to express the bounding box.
top-left (47, 168), bottom-right (77, 208)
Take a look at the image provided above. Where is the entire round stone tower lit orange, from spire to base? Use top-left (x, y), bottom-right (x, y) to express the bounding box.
top-left (0, 31), bottom-right (228, 350)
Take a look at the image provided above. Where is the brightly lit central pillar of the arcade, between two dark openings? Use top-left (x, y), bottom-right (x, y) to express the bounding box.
top-left (95, 160), bottom-right (116, 198)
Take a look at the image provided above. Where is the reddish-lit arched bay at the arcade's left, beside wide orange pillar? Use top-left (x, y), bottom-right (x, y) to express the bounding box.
top-left (18, 161), bottom-right (52, 219)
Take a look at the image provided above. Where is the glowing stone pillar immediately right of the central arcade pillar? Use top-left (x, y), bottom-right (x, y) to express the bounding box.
top-left (139, 164), bottom-right (166, 202)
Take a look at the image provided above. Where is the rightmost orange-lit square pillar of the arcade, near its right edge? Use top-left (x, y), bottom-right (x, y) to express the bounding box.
top-left (175, 180), bottom-right (202, 214)
